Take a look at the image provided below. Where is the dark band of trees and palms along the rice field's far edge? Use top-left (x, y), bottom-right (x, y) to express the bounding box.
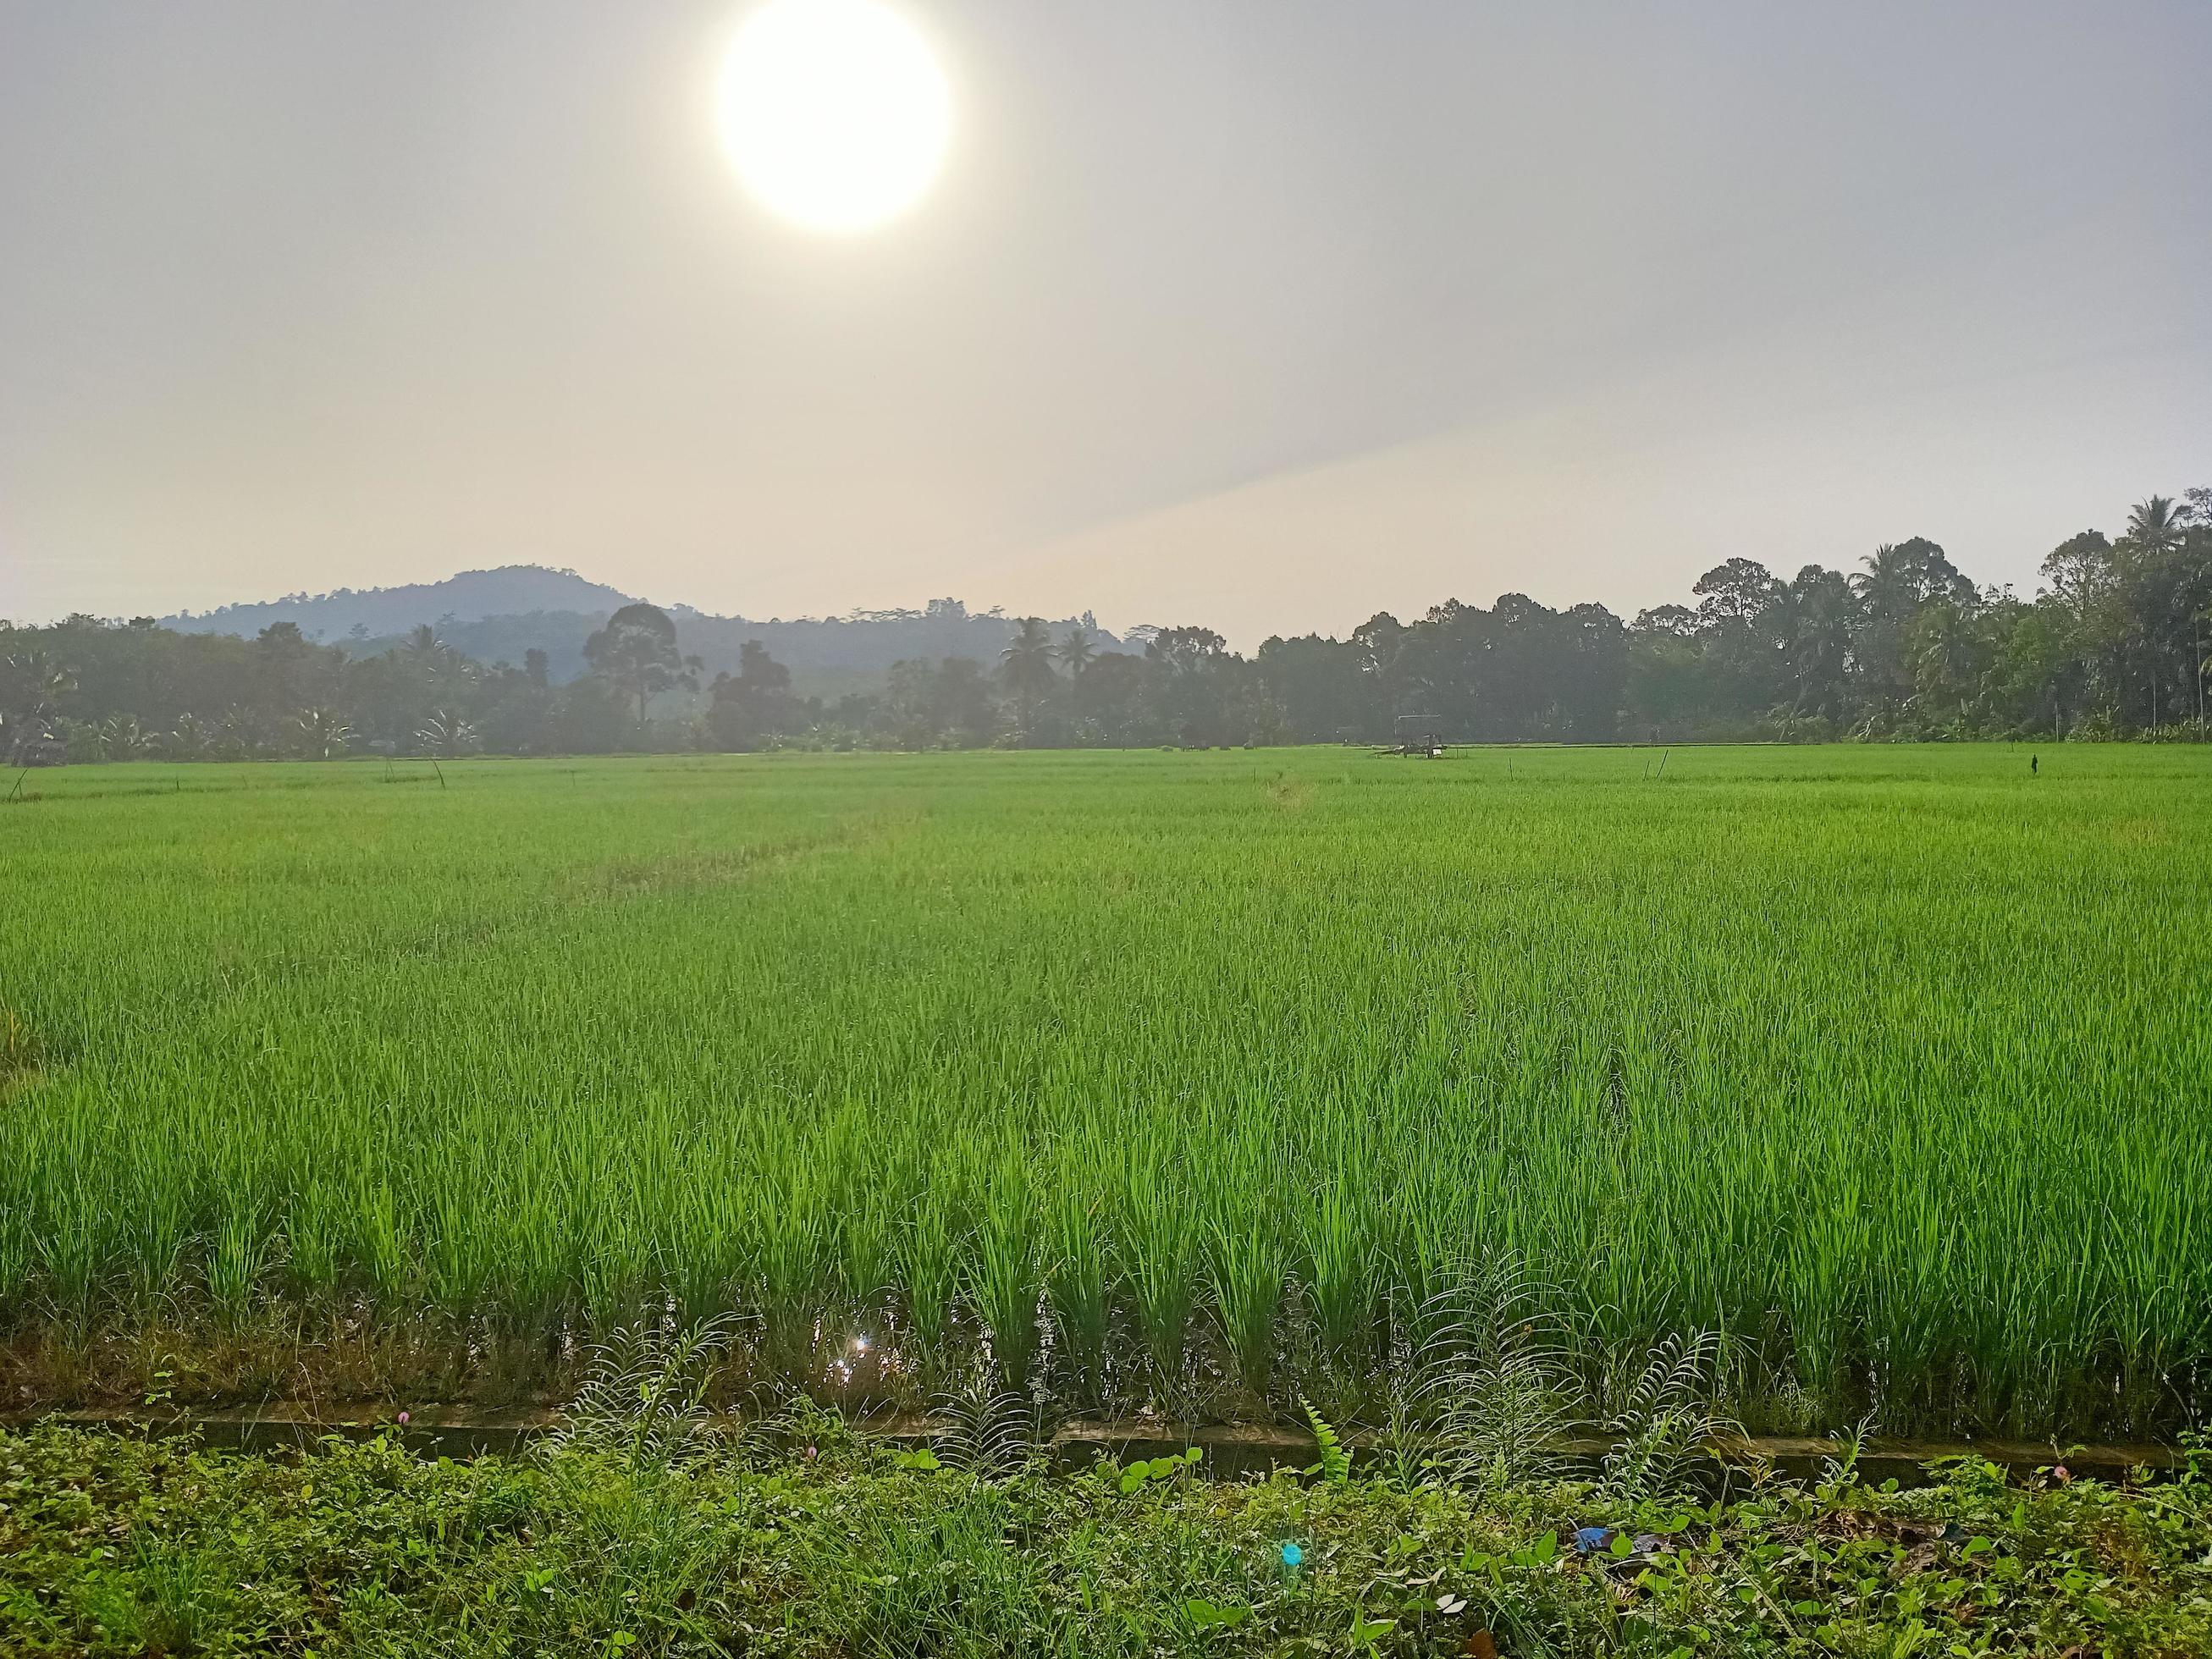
top-left (0, 489), bottom-right (2212, 763)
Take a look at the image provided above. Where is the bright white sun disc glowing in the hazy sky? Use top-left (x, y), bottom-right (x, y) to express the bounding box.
top-left (714, 0), bottom-right (952, 232)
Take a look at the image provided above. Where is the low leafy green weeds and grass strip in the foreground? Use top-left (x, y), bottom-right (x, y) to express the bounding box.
top-left (0, 1420), bottom-right (2212, 1659)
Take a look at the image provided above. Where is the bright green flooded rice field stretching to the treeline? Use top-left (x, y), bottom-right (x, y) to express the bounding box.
top-left (0, 746), bottom-right (2212, 1436)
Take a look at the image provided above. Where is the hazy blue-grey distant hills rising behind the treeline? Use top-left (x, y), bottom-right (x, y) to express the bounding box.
top-left (162, 564), bottom-right (1141, 697)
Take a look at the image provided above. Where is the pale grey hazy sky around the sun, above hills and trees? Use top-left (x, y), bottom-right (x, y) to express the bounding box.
top-left (0, 0), bottom-right (2212, 646)
